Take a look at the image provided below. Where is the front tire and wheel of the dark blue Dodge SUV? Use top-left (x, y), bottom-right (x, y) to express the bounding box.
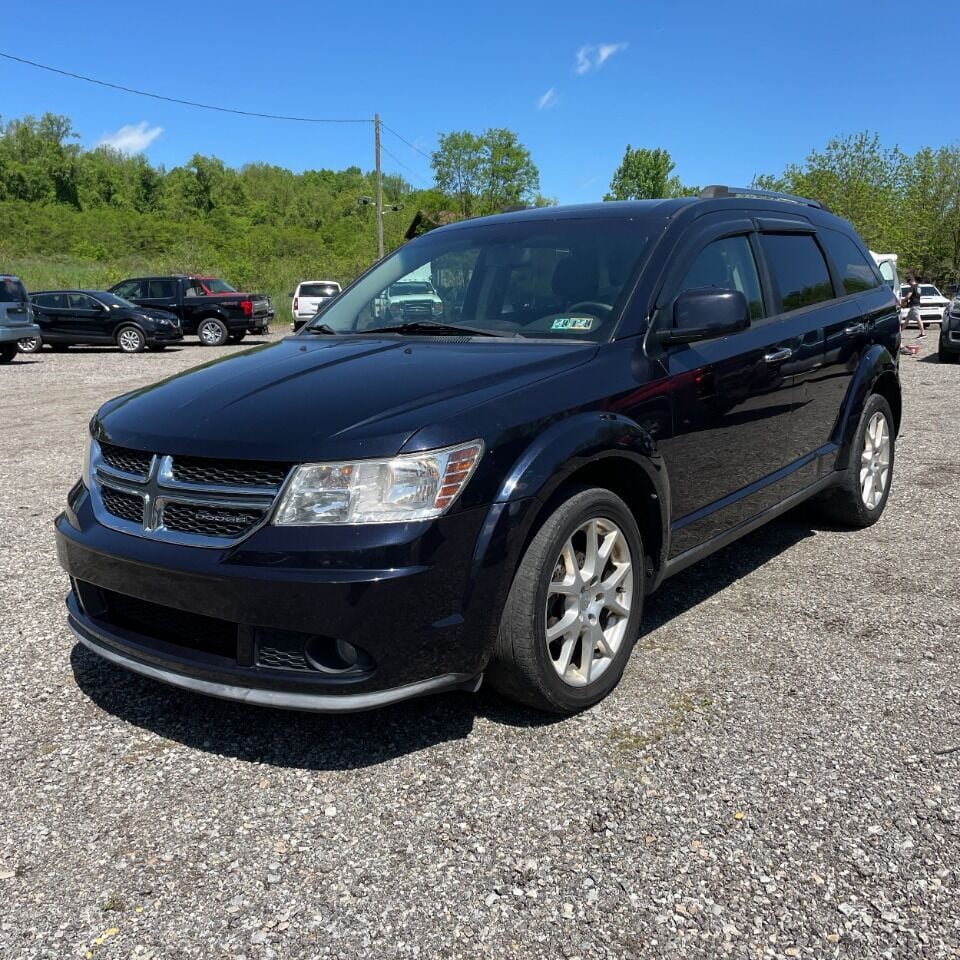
top-left (485, 487), bottom-right (644, 714)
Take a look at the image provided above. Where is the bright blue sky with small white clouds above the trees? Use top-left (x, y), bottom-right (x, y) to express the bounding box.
top-left (0, 0), bottom-right (960, 203)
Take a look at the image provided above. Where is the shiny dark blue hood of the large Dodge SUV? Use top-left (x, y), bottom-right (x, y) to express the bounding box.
top-left (95, 335), bottom-right (597, 462)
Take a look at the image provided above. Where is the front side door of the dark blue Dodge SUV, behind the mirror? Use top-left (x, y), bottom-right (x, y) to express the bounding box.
top-left (648, 219), bottom-right (794, 557)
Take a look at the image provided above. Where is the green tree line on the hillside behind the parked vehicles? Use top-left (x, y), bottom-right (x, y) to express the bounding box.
top-left (0, 114), bottom-right (960, 312)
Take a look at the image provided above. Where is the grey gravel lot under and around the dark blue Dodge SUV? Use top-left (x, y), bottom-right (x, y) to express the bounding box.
top-left (0, 334), bottom-right (960, 960)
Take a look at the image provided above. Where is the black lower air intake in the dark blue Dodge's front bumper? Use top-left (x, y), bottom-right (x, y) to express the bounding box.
top-left (100, 590), bottom-right (237, 659)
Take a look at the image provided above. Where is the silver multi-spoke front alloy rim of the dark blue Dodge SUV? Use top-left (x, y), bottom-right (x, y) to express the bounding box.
top-left (544, 517), bottom-right (634, 687)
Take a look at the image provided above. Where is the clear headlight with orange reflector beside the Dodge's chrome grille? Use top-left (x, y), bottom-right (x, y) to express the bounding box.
top-left (273, 440), bottom-right (483, 526)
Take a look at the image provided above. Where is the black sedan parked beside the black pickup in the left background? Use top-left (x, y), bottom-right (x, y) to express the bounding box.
top-left (19, 290), bottom-right (183, 353)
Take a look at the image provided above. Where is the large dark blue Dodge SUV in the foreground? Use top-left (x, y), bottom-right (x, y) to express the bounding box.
top-left (56, 187), bottom-right (901, 713)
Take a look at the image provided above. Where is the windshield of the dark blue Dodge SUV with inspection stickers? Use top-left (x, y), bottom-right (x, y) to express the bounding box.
top-left (306, 218), bottom-right (649, 342)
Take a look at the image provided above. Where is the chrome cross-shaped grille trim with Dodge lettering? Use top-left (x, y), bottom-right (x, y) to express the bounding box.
top-left (90, 440), bottom-right (292, 550)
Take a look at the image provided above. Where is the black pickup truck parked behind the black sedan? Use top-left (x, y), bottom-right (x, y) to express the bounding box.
top-left (110, 274), bottom-right (273, 347)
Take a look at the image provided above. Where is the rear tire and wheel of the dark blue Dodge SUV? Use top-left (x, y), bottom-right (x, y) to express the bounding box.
top-left (821, 393), bottom-right (896, 529)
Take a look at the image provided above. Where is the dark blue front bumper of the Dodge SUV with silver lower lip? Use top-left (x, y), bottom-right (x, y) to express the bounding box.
top-left (56, 485), bottom-right (526, 712)
